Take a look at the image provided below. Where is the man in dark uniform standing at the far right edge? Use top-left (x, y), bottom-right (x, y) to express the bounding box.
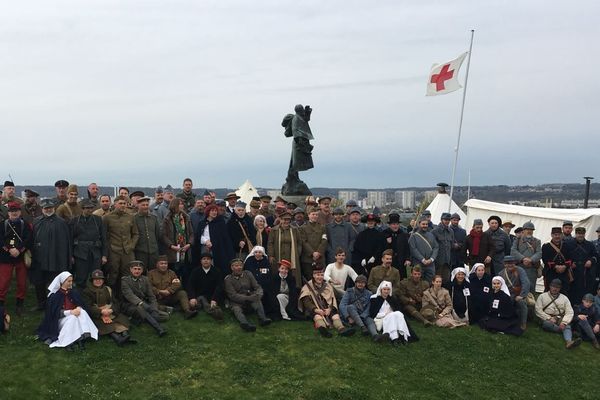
top-left (563, 226), bottom-right (598, 305)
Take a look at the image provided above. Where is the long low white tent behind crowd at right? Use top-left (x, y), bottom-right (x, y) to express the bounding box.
top-left (466, 199), bottom-right (600, 243)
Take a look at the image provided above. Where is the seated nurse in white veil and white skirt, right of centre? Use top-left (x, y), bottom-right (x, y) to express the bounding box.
top-left (369, 281), bottom-right (419, 345)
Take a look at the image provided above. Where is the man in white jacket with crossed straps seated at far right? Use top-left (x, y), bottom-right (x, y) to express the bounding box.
top-left (535, 279), bottom-right (581, 349)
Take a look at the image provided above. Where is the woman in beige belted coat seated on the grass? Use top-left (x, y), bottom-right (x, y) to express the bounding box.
top-left (421, 275), bottom-right (466, 329)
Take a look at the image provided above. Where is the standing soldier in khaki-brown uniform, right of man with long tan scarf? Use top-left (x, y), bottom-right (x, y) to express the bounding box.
top-left (299, 208), bottom-right (327, 281)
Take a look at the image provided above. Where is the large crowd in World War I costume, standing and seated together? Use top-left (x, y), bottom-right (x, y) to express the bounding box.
top-left (0, 178), bottom-right (600, 349)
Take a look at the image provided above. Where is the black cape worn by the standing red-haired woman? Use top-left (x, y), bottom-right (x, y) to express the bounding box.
top-left (194, 215), bottom-right (235, 276)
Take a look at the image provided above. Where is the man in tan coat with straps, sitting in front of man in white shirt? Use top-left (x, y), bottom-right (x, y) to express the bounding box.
top-left (298, 265), bottom-right (354, 338)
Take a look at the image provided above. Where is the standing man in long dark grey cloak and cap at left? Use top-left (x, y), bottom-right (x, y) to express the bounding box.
top-left (29, 199), bottom-right (72, 311)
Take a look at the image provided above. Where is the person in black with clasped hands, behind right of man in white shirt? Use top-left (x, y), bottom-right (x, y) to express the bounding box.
top-left (352, 214), bottom-right (385, 276)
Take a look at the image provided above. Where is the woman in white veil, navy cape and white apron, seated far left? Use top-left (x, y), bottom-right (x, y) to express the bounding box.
top-left (37, 271), bottom-right (98, 349)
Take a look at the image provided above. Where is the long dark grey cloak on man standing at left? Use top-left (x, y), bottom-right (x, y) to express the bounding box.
top-left (31, 214), bottom-right (72, 272)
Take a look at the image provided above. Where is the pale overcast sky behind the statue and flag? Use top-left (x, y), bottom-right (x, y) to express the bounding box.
top-left (0, 0), bottom-right (600, 188)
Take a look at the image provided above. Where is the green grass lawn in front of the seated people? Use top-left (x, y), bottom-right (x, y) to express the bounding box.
top-left (0, 290), bottom-right (600, 400)
